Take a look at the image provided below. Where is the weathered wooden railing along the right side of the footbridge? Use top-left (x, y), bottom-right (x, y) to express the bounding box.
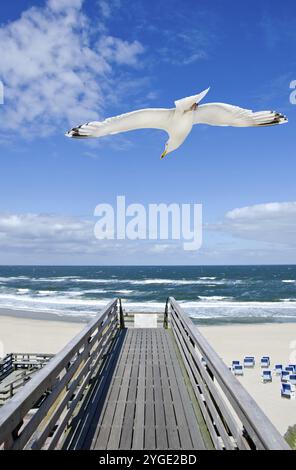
top-left (164, 297), bottom-right (289, 450)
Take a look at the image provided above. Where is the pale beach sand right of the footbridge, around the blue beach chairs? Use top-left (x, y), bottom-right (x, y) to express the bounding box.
top-left (199, 323), bottom-right (296, 435)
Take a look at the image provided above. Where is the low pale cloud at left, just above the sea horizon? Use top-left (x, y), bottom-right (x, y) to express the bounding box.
top-left (0, 213), bottom-right (181, 258)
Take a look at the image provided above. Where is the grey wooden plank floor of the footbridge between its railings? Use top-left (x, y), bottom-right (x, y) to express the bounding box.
top-left (91, 328), bottom-right (204, 449)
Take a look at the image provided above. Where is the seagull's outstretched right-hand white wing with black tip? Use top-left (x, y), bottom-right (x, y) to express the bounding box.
top-left (193, 103), bottom-right (288, 127)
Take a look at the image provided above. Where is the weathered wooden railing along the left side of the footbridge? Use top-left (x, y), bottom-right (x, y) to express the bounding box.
top-left (0, 300), bottom-right (119, 449)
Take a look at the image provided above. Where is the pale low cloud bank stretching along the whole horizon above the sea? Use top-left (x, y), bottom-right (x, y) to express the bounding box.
top-left (0, 201), bottom-right (296, 264)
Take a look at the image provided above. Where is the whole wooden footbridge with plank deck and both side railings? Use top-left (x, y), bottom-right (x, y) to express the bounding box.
top-left (0, 298), bottom-right (289, 450)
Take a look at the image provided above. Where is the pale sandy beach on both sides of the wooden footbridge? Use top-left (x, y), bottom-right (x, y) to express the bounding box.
top-left (0, 309), bottom-right (296, 434)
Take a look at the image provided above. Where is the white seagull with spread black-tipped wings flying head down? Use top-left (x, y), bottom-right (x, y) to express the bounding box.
top-left (65, 88), bottom-right (288, 158)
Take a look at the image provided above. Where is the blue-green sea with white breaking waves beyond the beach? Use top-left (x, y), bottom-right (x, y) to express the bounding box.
top-left (0, 265), bottom-right (296, 324)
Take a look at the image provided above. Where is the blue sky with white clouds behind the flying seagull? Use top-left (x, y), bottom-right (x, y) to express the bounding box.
top-left (0, 0), bottom-right (296, 264)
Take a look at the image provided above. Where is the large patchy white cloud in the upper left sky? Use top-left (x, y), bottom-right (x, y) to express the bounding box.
top-left (0, 0), bottom-right (144, 136)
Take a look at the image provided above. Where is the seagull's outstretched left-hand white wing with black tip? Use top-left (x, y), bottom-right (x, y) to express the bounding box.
top-left (66, 108), bottom-right (174, 138)
